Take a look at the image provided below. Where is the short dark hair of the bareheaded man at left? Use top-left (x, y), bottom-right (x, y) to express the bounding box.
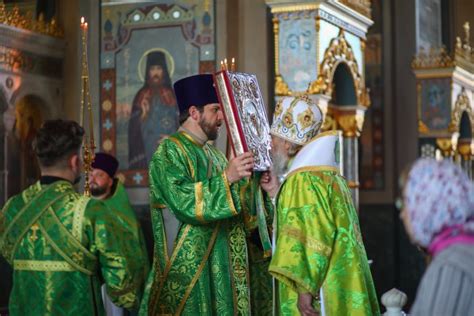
top-left (33, 120), bottom-right (84, 167)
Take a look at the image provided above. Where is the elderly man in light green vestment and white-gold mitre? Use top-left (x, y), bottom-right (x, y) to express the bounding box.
top-left (262, 96), bottom-right (379, 316)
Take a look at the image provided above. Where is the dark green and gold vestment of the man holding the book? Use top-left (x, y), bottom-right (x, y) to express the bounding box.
top-left (140, 132), bottom-right (271, 315)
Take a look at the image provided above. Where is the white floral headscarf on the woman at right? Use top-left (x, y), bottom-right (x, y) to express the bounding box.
top-left (404, 159), bottom-right (474, 247)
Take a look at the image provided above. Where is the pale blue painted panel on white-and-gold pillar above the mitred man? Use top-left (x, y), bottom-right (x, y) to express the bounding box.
top-left (278, 13), bottom-right (317, 92)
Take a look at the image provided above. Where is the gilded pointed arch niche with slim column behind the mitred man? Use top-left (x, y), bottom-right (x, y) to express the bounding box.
top-left (309, 29), bottom-right (370, 206)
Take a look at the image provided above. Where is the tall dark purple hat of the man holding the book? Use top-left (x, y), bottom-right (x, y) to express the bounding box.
top-left (174, 74), bottom-right (219, 113)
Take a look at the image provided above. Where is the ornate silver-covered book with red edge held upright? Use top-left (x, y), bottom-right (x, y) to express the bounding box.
top-left (214, 70), bottom-right (272, 171)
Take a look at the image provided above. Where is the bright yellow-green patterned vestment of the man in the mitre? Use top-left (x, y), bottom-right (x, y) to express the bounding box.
top-left (269, 167), bottom-right (380, 316)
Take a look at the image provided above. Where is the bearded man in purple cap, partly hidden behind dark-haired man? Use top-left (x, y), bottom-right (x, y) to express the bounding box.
top-left (90, 152), bottom-right (149, 316)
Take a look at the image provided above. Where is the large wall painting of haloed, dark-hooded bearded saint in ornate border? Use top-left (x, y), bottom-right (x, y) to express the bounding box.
top-left (100, 0), bottom-right (215, 187)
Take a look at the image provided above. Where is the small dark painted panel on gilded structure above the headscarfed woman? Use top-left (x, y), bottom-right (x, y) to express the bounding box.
top-left (419, 78), bottom-right (451, 132)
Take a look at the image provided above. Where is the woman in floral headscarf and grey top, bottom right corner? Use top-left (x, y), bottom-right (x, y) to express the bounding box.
top-left (400, 159), bottom-right (474, 315)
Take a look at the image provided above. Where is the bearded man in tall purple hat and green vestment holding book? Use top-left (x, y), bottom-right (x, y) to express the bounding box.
top-left (140, 75), bottom-right (270, 316)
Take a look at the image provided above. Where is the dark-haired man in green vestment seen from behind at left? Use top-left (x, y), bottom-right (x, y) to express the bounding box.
top-left (0, 120), bottom-right (143, 316)
